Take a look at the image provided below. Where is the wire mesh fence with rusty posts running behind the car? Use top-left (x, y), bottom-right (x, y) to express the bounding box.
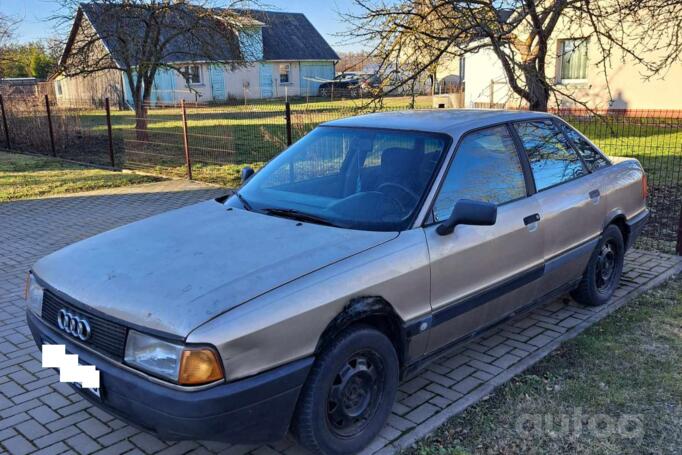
top-left (0, 96), bottom-right (682, 254)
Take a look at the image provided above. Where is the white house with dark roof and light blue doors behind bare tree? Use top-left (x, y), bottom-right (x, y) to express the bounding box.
top-left (54, 3), bottom-right (339, 105)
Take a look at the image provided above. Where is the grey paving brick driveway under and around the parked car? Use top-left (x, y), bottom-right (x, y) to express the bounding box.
top-left (0, 181), bottom-right (682, 454)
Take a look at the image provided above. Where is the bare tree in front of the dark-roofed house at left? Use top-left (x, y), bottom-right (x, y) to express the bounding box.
top-left (53, 0), bottom-right (260, 137)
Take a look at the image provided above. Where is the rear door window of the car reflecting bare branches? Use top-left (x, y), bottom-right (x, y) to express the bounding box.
top-left (515, 120), bottom-right (586, 191)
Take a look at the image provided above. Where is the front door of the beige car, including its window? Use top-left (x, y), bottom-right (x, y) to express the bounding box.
top-left (424, 125), bottom-right (543, 351)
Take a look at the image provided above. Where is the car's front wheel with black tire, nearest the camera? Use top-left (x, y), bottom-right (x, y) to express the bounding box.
top-left (292, 325), bottom-right (399, 455)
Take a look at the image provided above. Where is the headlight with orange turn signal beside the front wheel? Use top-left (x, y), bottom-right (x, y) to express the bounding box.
top-left (125, 330), bottom-right (223, 385)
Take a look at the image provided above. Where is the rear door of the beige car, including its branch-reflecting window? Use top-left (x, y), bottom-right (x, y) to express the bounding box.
top-left (514, 118), bottom-right (606, 295)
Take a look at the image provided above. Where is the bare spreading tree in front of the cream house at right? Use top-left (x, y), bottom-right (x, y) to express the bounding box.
top-left (345, 0), bottom-right (682, 111)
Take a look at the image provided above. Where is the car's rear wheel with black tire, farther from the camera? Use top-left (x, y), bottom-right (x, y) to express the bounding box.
top-left (571, 224), bottom-right (625, 306)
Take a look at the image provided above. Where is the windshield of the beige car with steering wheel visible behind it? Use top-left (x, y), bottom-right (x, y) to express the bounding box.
top-left (231, 126), bottom-right (450, 231)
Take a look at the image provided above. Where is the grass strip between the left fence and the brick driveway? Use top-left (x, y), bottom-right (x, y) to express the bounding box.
top-left (0, 152), bottom-right (161, 202)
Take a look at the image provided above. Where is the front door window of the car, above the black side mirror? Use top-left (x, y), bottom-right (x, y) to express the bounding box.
top-left (434, 126), bottom-right (526, 221)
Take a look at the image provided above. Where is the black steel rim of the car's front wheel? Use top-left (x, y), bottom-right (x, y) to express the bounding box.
top-left (326, 350), bottom-right (385, 438)
